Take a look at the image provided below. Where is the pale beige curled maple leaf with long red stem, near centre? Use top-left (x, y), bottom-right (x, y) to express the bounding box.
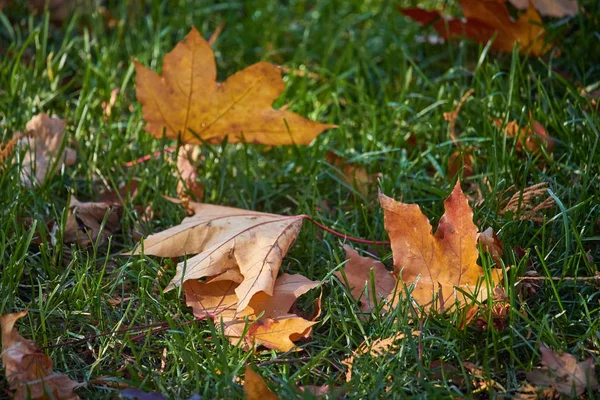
top-left (133, 202), bottom-right (304, 312)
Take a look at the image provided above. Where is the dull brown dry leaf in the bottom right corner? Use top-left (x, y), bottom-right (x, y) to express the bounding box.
top-left (527, 345), bottom-right (600, 396)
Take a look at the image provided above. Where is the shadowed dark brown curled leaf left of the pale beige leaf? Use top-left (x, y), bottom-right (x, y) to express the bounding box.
top-left (63, 196), bottom-right (123, 247)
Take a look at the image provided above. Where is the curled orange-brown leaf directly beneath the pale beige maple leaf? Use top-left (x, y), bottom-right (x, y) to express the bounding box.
top-left (183, 270), bottom-right (318, 351)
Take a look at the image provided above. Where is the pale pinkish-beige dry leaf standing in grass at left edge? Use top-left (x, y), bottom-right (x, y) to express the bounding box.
top-left (19, 114), bottom-right (77, 187)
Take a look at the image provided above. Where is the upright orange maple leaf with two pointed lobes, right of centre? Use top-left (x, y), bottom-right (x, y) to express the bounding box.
top-left (379, 182), bottom-right (503, 312)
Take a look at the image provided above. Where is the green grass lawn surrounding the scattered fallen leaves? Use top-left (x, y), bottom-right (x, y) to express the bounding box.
top-left (0, 0), bottom-right (600, 398)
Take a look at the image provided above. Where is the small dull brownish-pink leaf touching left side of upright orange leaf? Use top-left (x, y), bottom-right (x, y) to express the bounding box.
top-left (334, 245), bottom-right (398, 314)
